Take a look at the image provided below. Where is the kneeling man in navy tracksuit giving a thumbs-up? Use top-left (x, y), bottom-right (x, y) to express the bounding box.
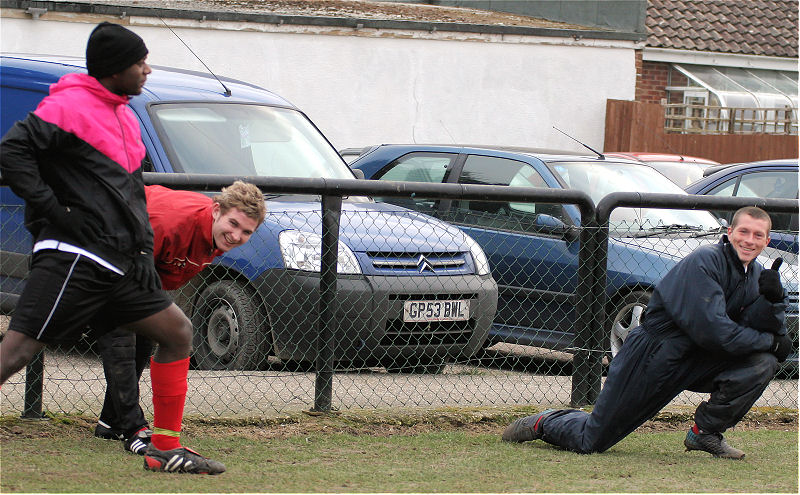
top-left (503, 207), bottom-right (792, 459)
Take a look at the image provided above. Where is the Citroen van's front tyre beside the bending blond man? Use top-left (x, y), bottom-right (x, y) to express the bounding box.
top-left (192, 280), bottom-right (270, 370)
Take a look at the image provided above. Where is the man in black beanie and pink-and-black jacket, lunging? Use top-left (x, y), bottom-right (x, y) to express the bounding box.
top-left (0, 22), bottom-right (225, 474)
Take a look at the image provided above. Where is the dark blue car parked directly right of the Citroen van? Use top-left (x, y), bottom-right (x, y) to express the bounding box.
top-left (350, 145), bottom-right (797, 364)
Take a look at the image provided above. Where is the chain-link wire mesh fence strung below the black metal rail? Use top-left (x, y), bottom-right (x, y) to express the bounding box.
top-left (0, 174), bottom-right (798, 416)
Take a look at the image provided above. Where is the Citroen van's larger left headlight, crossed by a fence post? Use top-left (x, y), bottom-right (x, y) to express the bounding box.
top-left (278, 230), bottom-right (361, 274)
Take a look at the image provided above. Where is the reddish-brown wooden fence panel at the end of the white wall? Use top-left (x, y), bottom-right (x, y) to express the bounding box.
top-left (603, 100), bottom-right (798, 163)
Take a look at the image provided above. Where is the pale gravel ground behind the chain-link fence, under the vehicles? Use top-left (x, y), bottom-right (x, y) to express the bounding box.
top-left (0, 344), bottom-right (798, 417)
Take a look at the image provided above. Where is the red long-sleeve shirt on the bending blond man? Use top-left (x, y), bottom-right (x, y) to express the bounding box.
top-left (144, 186), bottom-right (223, 290)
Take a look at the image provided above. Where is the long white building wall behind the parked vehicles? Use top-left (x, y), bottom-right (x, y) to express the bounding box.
top-left (0, 14), bottom-right (636, 150)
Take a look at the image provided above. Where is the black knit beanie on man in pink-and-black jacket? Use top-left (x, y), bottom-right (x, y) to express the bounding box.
top-left (86, 22), bottom-right (147, 79)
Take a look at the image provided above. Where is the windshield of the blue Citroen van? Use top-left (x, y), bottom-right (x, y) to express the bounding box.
top-left (150, 102), bottom-right (353, 179)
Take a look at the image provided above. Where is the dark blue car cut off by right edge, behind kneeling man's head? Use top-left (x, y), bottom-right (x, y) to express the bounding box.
top-left (686, 158), bottom-right (798, 254)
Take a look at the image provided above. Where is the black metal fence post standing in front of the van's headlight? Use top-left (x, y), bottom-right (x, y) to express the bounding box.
top-left (313, 196), bottom-right (342, 412)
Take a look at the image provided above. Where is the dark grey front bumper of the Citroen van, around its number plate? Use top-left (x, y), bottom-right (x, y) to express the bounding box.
top-left (254, 270), bottom-right (497, 361)
